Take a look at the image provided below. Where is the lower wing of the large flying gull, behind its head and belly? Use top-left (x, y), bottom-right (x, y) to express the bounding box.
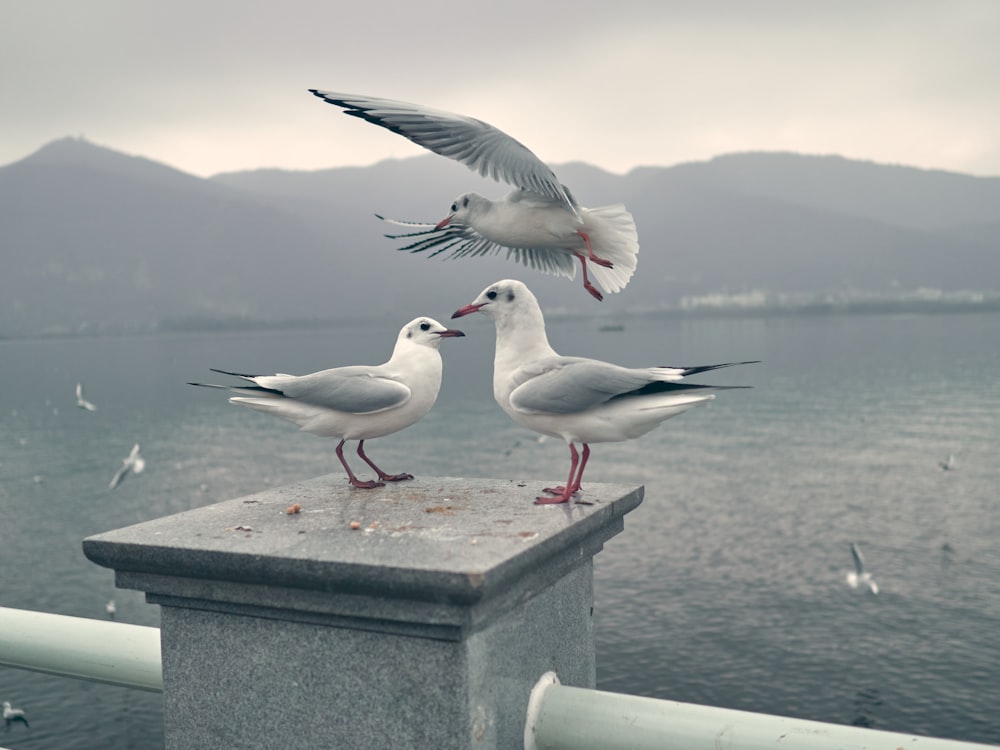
top-left (375, 214), bottom-right (576, 279)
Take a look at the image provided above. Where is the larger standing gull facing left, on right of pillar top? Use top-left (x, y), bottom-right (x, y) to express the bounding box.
top-left (452, 279), bottom-right (752, 505)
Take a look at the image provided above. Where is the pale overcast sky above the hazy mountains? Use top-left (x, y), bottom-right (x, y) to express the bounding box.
top-left (0, 0), bottom-right (1000, 176)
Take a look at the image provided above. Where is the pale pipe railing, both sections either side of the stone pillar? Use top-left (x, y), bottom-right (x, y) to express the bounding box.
top-left (0, 607), bottom-right (995, 750)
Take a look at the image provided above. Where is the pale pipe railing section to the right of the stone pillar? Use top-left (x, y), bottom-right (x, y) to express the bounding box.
top-left (524, 672), bottom-right (995, 750)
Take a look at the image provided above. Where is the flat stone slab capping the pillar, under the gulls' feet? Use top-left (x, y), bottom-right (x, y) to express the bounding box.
top-left (83, 474), bottom-right (643, 603)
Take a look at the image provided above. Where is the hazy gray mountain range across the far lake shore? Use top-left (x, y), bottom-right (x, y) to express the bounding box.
top-left (0, 138), bottom-right (1000, 335)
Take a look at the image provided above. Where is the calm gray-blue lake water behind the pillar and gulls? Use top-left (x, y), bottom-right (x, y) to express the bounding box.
top-left (0, 315), bottom-right (1000, 748)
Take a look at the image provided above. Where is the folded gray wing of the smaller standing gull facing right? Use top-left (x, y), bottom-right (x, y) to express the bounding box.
top-left (255, 365), bottom-right (410, 414)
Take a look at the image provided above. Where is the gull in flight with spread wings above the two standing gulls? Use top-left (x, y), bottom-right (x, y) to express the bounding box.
top-left (309, 89), bottom-right (639, 300)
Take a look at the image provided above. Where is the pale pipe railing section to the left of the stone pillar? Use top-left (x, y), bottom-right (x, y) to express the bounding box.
top-left (0, 607), bottom-right (163, 692)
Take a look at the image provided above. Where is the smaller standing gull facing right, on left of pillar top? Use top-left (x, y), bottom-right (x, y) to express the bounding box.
top-left (190, 318), bottom-right (465, 489)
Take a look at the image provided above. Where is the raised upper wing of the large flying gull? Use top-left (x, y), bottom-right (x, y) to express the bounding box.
top-left (309, 89), bottom-right (575, 211)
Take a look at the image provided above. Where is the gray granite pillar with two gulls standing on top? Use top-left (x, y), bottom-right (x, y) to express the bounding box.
top-left (83, 475), bottom-right (643, 750)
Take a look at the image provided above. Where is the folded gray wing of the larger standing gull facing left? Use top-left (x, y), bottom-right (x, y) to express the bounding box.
top-left (510, 356), bottom-right (667, 414)
